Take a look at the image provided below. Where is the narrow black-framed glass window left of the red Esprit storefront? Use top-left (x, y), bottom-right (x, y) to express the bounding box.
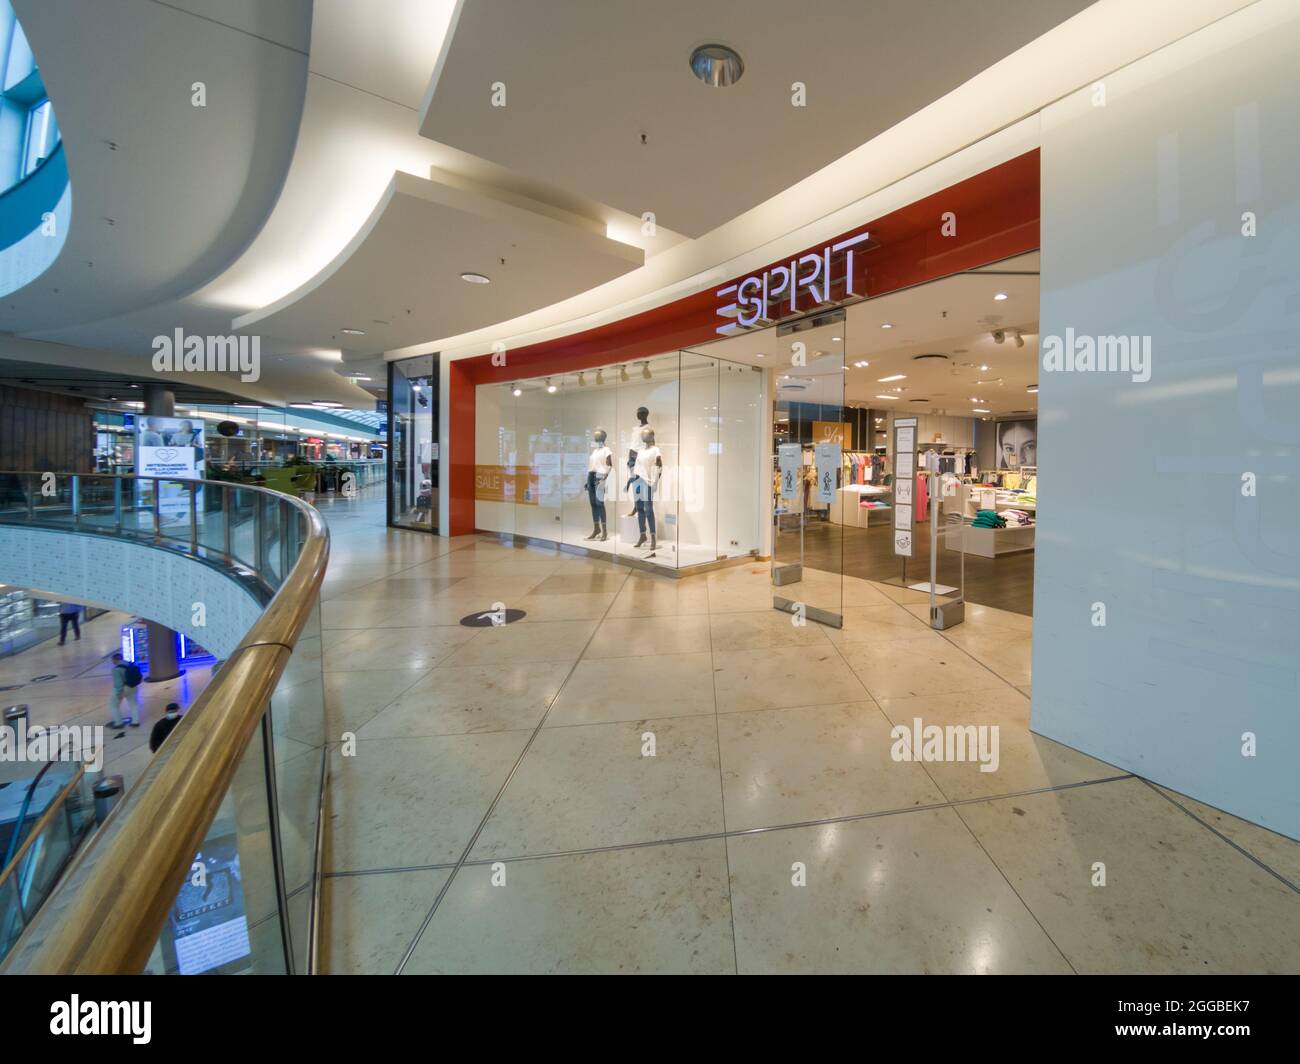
top-left (389, 355), bottom-right (438, 532)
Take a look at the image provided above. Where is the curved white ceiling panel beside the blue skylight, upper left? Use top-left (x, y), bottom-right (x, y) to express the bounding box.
top-left (0, 0), bottom-right (312, 329)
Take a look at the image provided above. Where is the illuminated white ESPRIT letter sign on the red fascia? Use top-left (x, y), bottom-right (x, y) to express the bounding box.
top-left (715, 233), bottom-right (871, 334)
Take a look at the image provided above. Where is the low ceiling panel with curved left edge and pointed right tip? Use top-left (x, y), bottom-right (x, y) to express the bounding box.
top-left (234, 173), bottom-right (645, 351)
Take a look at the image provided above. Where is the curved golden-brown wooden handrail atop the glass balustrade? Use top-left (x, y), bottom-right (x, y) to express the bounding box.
top-left (4, 473), bottom-right (329, 974)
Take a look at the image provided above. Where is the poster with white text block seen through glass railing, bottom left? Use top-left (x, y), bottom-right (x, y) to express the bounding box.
top-left (163, 835), bottom-right (252, 976)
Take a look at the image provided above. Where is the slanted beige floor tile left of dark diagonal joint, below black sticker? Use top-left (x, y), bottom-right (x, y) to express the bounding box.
top-left (358, 661), bottom-right (572, 739)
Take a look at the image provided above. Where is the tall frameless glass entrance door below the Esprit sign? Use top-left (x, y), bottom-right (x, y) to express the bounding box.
top-left (771, 311), bottom-right (853, 628)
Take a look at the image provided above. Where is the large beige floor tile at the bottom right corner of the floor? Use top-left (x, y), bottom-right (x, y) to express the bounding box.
top-left (957, 779), bottom-right (1300, 974)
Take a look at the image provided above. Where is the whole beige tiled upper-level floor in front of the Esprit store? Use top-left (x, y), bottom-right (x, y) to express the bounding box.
top-left (324, 489), bottom-right (1300, 973)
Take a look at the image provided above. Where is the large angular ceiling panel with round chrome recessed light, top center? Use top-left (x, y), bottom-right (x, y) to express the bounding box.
top-left (420, 0), bottom-right (1092, 237)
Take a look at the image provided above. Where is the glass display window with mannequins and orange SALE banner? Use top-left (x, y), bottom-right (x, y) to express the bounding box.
top-left (475, 351), bottom-right (764, 570)
